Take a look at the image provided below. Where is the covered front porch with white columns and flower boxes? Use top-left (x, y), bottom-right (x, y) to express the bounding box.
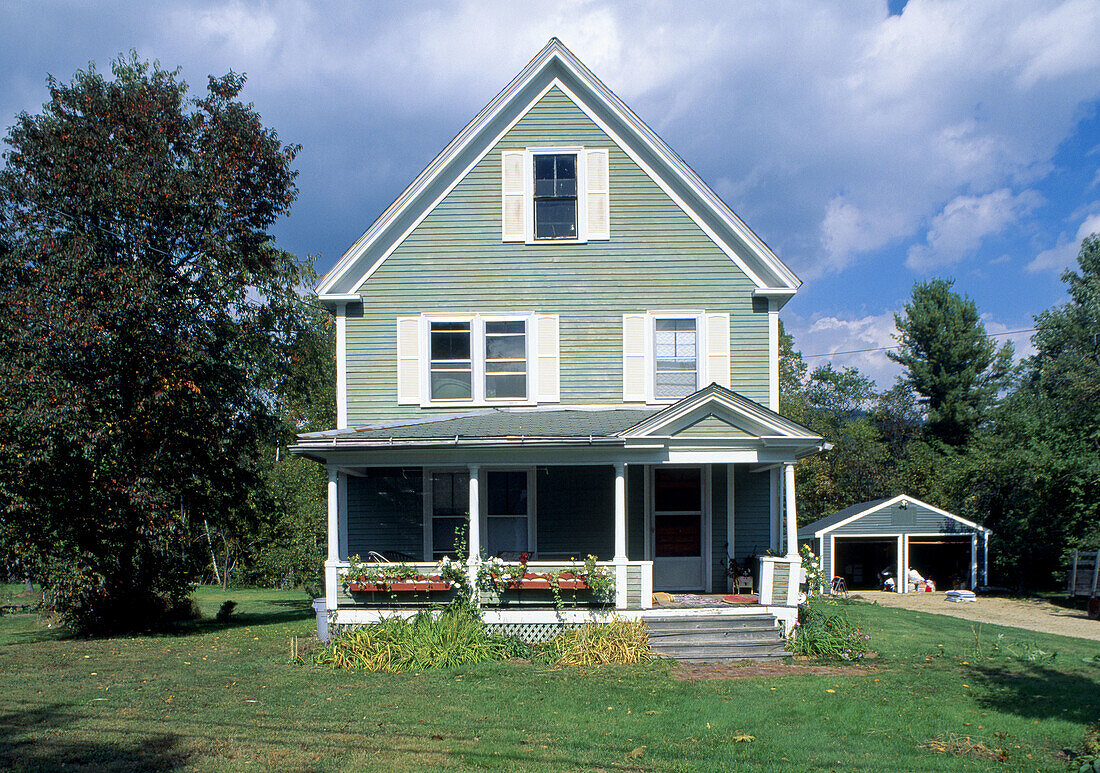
top-left (293, 386), bottom-right (821, 642)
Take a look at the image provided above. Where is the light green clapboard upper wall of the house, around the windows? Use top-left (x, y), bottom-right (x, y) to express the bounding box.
top-left (348, 89), bottom-right (768, 426)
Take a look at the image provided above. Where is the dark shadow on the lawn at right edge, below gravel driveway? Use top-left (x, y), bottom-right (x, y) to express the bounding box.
top-left (975, 664), bottom-right (1100, 724)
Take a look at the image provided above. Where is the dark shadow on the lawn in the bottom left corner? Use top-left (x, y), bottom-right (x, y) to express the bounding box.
top-left (0, 704), bottom-right (190, 771)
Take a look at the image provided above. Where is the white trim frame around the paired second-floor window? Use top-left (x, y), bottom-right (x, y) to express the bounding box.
top-left (420, 312), bottom-right (538, 408)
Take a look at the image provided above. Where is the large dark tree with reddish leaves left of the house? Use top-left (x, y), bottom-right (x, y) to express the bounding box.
top-left (0, 55), bottom-right (310, 631)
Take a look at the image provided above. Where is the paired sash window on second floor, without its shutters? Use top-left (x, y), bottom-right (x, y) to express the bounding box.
top-left (428, 317), bottom-right (528, 401)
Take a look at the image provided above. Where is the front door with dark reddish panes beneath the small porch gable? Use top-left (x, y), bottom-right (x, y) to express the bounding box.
top-left (652, 467), bottom-right (704, 590)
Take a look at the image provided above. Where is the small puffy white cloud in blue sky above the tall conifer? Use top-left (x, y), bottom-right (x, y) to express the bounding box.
top-left (905, 188), bottom-right (1042, 272)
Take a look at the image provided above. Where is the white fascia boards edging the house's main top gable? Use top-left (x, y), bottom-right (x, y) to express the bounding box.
top-left (318, 38), bottom-right (802, 295)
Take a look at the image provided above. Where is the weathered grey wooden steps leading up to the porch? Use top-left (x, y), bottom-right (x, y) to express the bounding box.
top-left (644, 615), bottom-right (791, 661)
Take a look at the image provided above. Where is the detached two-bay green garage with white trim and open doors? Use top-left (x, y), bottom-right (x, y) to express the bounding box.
top-left (799, 495), bottom-right (990, 593)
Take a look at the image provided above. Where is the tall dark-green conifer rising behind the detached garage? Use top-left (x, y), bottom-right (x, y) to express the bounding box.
top-left (887, 279), bottom-right (1012, 446)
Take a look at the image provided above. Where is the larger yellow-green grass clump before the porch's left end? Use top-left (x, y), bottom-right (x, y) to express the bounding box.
top-left (314, 605), bottom-right (516, 673)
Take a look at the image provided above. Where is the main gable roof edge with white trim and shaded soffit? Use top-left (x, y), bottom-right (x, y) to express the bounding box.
top-left (317, 37), bottom-right (802, 306)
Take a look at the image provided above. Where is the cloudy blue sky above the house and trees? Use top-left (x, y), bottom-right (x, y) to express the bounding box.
top-left (0, 0), bottom-right (1100, 386)
